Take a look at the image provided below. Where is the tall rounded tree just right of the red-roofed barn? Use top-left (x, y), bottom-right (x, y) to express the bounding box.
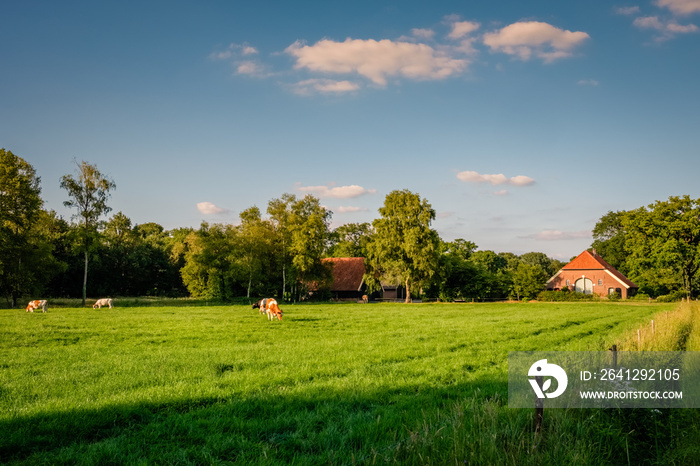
top-left (365, 190), bottom-right (439, 302)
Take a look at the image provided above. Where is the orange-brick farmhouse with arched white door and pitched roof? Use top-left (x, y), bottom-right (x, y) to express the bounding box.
top-left (547, 249), bottom-right (639, 299)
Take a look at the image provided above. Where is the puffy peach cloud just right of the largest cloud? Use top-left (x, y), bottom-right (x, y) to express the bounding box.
top-left (484, 21), bottom-right (590, 63)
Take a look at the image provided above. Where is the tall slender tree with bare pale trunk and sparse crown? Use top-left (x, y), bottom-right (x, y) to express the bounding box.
top-left (61, 161), bottom-right (116, 305)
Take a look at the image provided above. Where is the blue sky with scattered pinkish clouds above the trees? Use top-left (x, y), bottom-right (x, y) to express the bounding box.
top-left (0, 0), bottom-right (700, 260)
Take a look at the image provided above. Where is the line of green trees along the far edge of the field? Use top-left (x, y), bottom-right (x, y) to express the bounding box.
top-left (5, 149), bottom-right (644, 306)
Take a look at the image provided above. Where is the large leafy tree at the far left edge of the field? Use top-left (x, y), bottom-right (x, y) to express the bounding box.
top-left (0, 149), bottom-right (56, 307)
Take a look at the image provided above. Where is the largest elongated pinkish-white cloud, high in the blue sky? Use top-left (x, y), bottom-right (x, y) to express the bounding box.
top-left (285, 39), bottom-right (468, 86)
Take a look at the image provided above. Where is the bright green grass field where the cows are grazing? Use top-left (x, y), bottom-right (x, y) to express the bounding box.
top-left (0, 302), bottom-right (700, 465)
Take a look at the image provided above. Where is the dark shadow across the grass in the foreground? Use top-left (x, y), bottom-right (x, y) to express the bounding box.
top-left (0, 374), bottom-right (699, 464)
